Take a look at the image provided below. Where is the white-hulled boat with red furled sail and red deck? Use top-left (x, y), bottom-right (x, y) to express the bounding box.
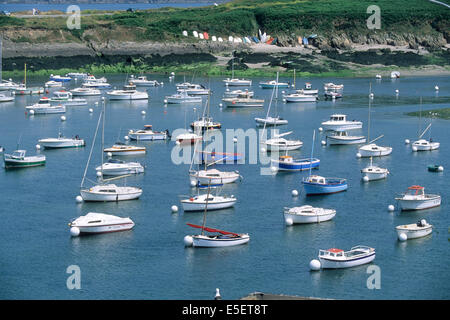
top-left (184, 223), bottom-right (250, 248)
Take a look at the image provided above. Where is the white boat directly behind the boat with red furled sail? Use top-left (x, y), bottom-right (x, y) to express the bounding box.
top-left (181, 194), bottom-right (237, 211)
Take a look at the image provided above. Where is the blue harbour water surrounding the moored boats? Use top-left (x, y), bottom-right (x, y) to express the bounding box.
top-left (0, 75), bottom-right (450, 299)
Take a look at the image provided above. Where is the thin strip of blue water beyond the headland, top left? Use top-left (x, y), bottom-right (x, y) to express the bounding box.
top-left (0, 1), bottom-right (218, 12)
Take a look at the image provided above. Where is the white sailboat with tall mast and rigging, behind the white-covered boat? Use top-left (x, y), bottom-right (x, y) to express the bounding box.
top-left (80, 100), bottom-right (142, 201)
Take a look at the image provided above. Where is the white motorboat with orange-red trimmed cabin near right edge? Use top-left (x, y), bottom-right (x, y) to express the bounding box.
top-left (395, 186), bottom-right (441, 211)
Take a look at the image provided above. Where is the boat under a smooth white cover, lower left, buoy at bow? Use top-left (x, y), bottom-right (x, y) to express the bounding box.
top-left (69, 212), bottom-right (134, 236)
